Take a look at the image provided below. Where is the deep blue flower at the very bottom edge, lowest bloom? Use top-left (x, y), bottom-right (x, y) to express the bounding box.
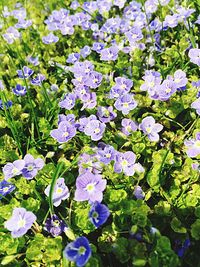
top-left (64, 236), bottom-right (91, 267)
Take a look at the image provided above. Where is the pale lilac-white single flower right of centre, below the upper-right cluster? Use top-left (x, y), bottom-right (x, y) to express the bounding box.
top-left (139, 116), bottom-right (163, 142)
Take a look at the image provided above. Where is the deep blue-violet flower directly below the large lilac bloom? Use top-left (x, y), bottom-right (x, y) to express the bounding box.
top-left (89, 202), bottom-right (110, 228)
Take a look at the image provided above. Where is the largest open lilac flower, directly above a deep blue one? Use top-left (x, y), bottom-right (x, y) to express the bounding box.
top-left (74, 171), bottom-right (107, 202)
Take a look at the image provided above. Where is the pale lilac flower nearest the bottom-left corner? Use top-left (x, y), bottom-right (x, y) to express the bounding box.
top-left (4, 208), bottom-right (36, 238)
